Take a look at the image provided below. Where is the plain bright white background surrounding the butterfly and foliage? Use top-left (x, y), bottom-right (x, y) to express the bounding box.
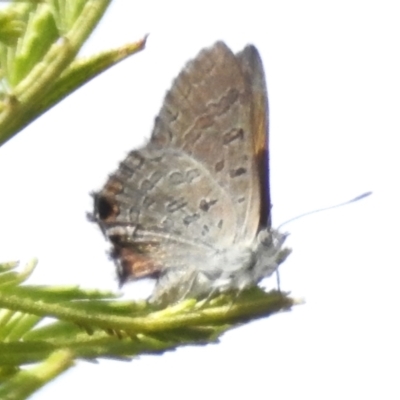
top-left (0, 0), bottom-right (400, 400)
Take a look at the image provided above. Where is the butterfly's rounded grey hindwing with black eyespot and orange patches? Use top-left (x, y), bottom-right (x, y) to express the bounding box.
top-left (94, 144), bottom-right (236, 281)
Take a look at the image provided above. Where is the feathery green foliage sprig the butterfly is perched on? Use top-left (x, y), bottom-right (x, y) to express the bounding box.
top-left (0, 262), bottom-right (293, 399)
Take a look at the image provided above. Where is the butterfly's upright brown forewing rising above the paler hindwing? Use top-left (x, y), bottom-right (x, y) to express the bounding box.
top-left (151, 42), bottom-right (269, 243)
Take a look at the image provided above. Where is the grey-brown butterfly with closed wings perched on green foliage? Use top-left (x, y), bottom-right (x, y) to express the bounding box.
top-left (92, 42), bottom-right (290, 304)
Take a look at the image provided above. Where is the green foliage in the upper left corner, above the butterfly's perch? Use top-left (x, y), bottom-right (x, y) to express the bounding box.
top-left (0, 0), bottom-right (145, 145)
